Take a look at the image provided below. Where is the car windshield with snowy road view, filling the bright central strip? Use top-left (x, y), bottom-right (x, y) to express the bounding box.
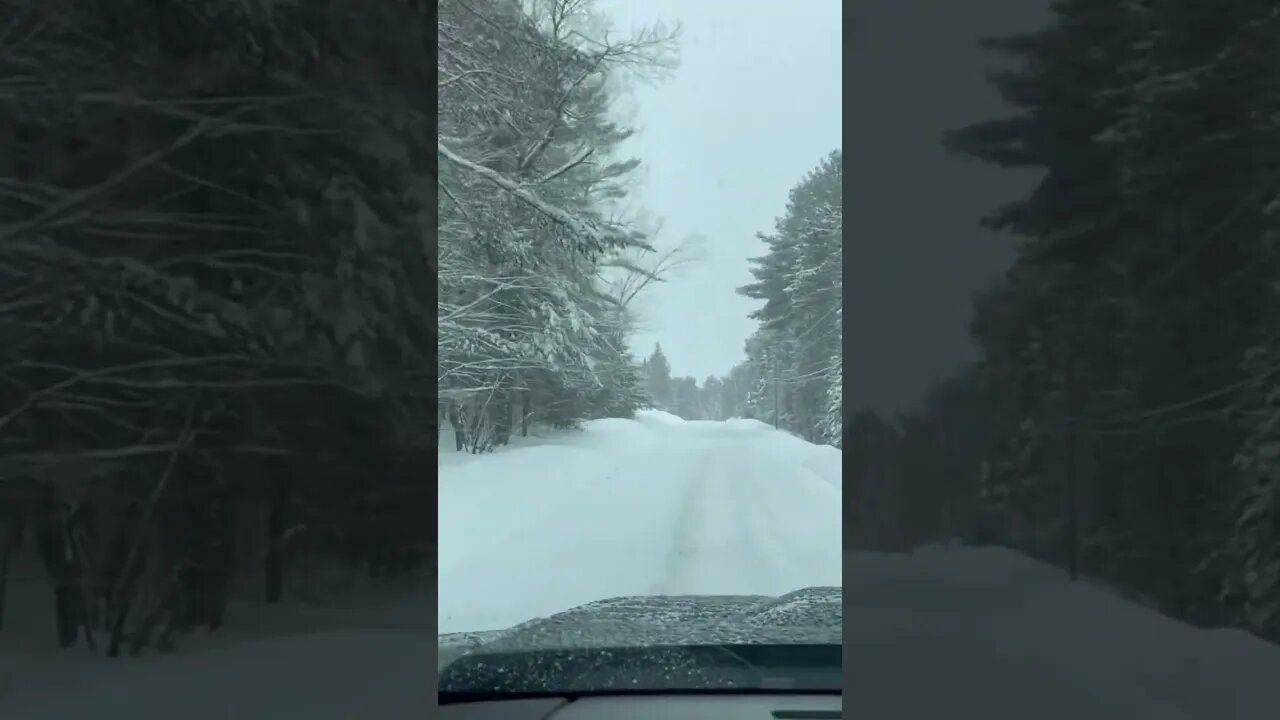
top-left (438, 0), bottom-right (844, 692)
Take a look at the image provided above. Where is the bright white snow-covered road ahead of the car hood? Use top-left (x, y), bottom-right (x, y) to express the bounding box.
top-left (439, 413), bottom-right (841, 633)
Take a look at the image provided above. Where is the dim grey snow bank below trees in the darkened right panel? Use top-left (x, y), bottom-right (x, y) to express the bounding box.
top-left (844, 546), bottom-right (1280, 720)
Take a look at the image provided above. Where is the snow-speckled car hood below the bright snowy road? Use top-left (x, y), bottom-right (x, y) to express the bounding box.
top-left (439, 587), bottom-right (842, 667)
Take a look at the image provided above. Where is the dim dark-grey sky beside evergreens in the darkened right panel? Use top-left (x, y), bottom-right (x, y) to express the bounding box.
top-left (845, 0), bottom-right (1048, 411)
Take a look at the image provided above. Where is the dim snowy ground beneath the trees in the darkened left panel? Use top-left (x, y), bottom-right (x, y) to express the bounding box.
top-left (0, 564), bottom-right (435, 720)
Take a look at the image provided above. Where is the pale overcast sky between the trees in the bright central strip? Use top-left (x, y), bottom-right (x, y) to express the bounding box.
top-left (596, 0), bottom-right (841, 382)
